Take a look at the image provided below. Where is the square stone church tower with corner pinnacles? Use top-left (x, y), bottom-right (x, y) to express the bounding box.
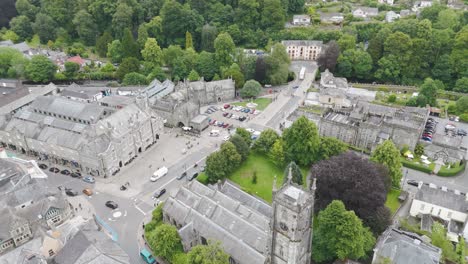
top-left (265, 169), bottom-right (315, 264)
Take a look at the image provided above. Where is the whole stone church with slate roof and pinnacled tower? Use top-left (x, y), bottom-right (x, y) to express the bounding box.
top-left (163, 170), bottom-right (315, 264)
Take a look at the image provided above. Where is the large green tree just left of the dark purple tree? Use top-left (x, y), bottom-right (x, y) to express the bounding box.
top-left (283, 116), bottom-right (320, 166)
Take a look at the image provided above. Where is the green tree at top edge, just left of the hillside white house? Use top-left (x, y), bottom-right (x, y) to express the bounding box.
top-left (260, 0), bottom-right (286, 31)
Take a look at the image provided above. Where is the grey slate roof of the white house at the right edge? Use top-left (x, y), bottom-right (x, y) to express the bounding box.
top-left (414, 185), bottom-right (468, 213)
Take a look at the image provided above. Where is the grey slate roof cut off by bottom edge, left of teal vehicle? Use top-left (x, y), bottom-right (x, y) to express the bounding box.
top-left (53, 229), bottom-right (130, 264)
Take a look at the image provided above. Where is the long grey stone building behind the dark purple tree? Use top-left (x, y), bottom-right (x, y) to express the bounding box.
top-left (319, 101), bottom-right (429, 150)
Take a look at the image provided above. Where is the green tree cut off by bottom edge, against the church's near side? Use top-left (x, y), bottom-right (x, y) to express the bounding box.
top-left (187, 241), bottom-right (229, 264)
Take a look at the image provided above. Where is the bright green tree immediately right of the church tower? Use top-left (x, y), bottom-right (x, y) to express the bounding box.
top-left (312, 200), bottom-right (375, 262)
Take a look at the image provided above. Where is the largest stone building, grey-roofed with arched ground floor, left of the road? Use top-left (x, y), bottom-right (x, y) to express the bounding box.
top-left (0, 96), bottom-right (163, 177)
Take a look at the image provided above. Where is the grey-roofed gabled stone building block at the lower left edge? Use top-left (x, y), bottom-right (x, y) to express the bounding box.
top-left (0, 155), bottom-right (73, 255)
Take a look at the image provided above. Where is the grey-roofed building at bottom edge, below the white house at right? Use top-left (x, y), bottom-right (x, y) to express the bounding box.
top-left (372, 228), bottom-right (442, 264)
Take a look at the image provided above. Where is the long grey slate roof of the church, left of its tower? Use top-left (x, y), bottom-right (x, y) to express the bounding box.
top-left (163, 181), bottom-right (271, 263)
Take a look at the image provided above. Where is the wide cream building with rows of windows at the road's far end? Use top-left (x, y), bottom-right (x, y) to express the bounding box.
top-left (281, 40), bottom-right (325, 60)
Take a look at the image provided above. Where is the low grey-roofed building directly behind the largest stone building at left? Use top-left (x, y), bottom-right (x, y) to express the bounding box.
top-left (60, 83), bottom-right (111, 103)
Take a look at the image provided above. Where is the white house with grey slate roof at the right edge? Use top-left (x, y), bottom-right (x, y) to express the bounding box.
top-left (410, 182), bottom-right (468, 242)
